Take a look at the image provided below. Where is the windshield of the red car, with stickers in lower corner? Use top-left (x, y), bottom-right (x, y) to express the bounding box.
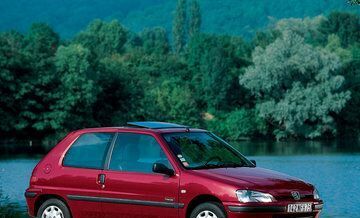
top-left (163, 132), bottom-right (253, 169)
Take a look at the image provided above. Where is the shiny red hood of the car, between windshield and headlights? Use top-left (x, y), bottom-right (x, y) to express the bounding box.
top-left (198, 167), bottom-right (314, 196)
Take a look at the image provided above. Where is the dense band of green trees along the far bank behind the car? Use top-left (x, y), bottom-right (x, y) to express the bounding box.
top-left (0, 0), bottom-right (360, 151)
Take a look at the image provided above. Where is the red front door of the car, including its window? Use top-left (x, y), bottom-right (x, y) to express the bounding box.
top-left (102, 133), bottom-right (181, 218)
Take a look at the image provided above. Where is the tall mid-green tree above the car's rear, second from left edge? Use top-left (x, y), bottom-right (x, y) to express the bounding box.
top-left (45, 44), bottom-right (98, 132)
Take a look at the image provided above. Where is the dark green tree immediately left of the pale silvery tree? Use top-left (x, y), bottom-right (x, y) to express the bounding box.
top-left (186, 34), bottom-right (248, 110)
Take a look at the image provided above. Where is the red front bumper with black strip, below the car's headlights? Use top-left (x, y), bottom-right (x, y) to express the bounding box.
top-left (224, 201), bottom-right (323, 218)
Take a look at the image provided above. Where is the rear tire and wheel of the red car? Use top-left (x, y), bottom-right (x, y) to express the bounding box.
top-left (36, 198), bottom-right (71, 218)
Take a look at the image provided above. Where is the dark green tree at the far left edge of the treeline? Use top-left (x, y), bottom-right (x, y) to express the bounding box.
top-left (1, 24), bottom-right (59, 137)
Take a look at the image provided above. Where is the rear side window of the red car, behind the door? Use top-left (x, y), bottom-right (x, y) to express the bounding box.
top-left (63, 133), bottom-right (114, 169)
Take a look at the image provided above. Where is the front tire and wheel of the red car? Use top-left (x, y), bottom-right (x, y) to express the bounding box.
top-left (190, 202), bottom-right (226, 218)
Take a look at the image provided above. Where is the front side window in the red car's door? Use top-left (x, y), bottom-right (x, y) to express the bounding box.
top-left (109, 133), bottom-right (172, 173)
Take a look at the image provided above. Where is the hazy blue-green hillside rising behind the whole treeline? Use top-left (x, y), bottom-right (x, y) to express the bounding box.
top-left (0, 0), bottom-right (360, 38)
